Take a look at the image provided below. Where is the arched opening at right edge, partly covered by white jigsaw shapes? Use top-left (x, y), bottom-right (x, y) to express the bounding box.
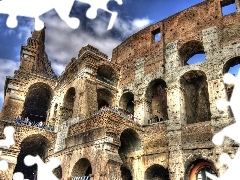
top-left (223, 56), bottom-right (240, 117)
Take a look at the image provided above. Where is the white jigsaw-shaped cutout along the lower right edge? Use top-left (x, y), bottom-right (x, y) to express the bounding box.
top-left (206, 70), bottom-right (240, 180)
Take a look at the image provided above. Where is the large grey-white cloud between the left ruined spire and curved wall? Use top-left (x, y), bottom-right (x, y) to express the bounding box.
top-left (40, 11), bottom-right (121, 75)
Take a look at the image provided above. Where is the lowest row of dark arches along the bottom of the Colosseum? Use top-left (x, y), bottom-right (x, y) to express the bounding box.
top-left (11, 128), bottom-right (218, 180)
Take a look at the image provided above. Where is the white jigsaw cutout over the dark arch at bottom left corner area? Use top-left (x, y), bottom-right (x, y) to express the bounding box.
top-left (13, 155), bottom-right (60, 180)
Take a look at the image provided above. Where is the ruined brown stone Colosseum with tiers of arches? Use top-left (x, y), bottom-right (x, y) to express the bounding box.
top-left (0, 0), bottom-right (240, 180)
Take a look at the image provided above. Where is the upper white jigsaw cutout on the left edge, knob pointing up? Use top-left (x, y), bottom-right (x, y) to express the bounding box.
top-left (0, 126), bottom-right (15, 149)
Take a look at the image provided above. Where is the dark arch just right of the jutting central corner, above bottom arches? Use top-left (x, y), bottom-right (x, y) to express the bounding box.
top-left (118, 129), bottom-right (141, 166)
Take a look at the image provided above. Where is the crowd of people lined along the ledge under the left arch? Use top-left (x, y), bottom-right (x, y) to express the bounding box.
top-left (14, 115), bottom-right (54, 131)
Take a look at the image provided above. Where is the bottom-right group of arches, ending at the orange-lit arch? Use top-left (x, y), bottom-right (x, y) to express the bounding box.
top-left (118, 129), bottom-right (218, 180)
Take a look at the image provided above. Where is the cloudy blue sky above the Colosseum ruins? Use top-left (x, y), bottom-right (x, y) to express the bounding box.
top-left (0, 0), bottom-right (237, 109)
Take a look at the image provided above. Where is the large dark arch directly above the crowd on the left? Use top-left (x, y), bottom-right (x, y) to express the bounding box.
top-left (22, 83), bottom-right (52, 122)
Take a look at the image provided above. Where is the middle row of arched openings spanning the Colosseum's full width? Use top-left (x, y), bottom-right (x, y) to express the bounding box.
top-left (21, 55), bottom-right (240, 123)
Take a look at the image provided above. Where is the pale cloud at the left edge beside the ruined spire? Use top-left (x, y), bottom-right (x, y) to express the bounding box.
top-left (0, 59), bottom-right (19, 110)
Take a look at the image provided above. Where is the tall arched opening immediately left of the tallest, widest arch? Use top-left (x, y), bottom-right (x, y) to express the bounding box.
top-left (146, 79), bottom-right (168, 122)
